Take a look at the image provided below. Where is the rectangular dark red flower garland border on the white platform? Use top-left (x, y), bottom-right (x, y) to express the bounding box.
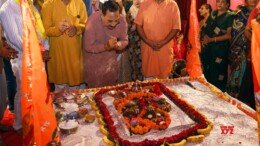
top-left (94, 82), bottom-right (209, 146)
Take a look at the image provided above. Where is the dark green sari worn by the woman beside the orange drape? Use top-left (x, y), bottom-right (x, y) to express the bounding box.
top-left (201, 11), bottom-right (233, 91)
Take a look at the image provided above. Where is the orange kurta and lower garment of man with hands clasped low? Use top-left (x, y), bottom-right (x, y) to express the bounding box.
top-left (135, 0), bottom-right (181, 78)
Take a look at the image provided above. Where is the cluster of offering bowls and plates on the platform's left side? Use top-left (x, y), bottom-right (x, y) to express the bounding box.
top-left (54, 91), bottom-right (96, 135)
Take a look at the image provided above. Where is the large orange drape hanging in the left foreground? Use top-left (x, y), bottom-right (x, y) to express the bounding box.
top-left (21, 0), bottom-right (57, 146)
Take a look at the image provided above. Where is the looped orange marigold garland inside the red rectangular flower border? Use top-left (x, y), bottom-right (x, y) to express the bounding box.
top-left (114, 90), bottom-right (171, 134)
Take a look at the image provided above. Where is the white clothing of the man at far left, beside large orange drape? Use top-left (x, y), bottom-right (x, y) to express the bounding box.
top-left (0, 0), bottom-right (23, 130)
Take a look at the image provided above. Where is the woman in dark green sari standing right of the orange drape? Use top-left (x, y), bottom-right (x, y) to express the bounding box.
top-left (201, 0), bottom-right (233, 91)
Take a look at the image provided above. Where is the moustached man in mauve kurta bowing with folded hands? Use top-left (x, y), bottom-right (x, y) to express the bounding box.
top-left (83, 0), bottom-right (128, 88)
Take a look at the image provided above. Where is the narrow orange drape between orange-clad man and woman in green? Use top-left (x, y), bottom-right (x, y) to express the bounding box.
top-left (186, 0), bottom-right (202, 77)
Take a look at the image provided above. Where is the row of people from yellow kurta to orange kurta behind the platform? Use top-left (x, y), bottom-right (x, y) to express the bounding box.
top-left (42, 0), bottom-right (181, 90)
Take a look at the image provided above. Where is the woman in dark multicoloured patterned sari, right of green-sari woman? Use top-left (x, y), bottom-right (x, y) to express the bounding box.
top-left (227, 0), bottom-right (258, 98)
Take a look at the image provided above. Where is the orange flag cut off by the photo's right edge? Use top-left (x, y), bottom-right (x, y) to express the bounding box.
top-left (251, 19), bottom-right (260, 141)
